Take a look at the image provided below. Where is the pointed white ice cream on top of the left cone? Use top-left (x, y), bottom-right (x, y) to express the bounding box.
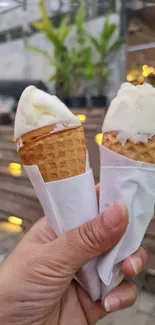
top-left (15, 86), bottom-right (81, 140)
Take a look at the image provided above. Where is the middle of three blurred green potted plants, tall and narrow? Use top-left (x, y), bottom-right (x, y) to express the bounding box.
top-left (65, 0), bottom-right (95, 108)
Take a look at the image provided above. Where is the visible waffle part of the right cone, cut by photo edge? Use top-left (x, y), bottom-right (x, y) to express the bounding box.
top-left (102, 132), bottom-right (155, 164)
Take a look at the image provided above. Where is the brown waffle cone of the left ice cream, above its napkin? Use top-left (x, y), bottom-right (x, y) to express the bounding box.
top-left (17, 125), bottom-right (86, 182)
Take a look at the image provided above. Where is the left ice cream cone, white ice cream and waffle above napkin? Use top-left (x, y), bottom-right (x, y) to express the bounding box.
top-left (15, 86), bottom-right (86, 182)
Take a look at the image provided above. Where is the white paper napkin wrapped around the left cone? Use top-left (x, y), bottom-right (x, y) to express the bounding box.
top-left (24, 166), bottom-right (102, 301)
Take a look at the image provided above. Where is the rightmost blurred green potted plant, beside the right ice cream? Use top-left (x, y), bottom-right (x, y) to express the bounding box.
top-left (89, 15), bottom-right (123, 107)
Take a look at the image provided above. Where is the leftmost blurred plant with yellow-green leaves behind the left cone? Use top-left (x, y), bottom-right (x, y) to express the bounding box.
top-left (28, 0), bottom-right (72, 98)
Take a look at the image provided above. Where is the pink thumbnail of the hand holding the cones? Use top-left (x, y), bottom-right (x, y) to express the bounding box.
top-left (104, 201), bottom-right (126, 228)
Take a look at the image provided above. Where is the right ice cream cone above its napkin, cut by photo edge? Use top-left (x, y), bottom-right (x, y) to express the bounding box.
top-left (102, 83), bottom-right (155, 164)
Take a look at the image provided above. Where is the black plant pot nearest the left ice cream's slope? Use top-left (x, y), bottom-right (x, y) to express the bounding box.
top-left (63, 96), bottom-right (87, 109)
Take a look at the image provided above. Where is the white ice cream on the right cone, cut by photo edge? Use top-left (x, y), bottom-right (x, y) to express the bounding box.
top-left (102, 82), bottom-right (155, 140)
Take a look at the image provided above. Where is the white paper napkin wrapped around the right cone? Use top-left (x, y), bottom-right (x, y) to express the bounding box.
top-left (98, 145), bottom-right (155, 297)
